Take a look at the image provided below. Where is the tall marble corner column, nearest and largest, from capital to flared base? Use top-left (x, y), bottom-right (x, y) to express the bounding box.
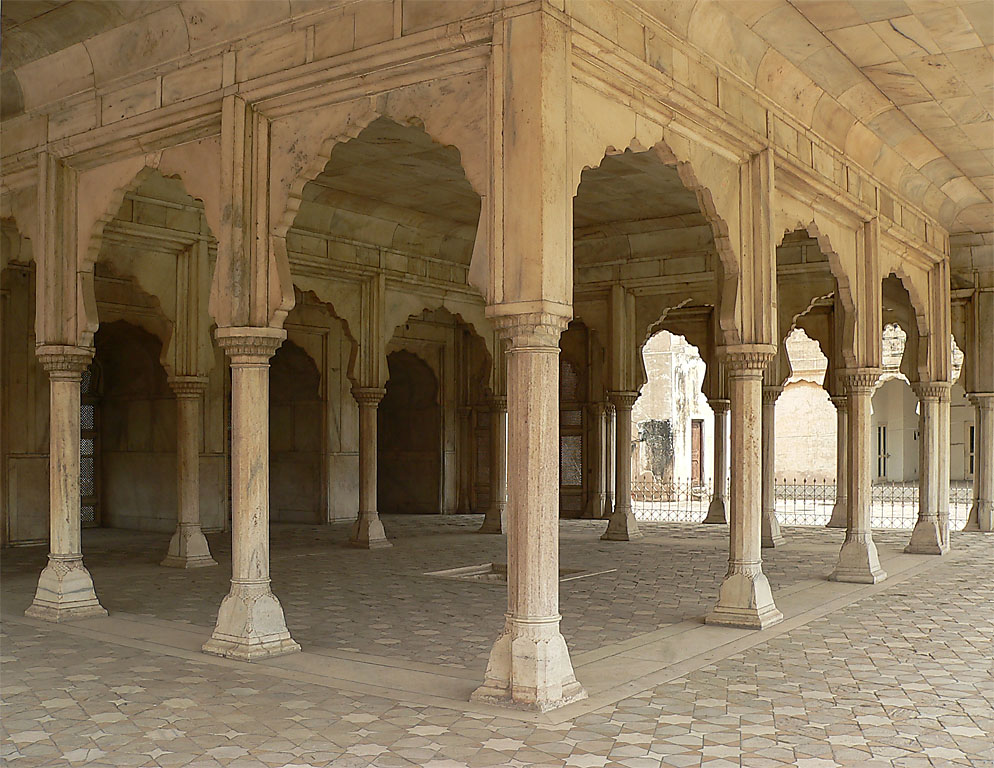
top-left (473, 314), bottom-right (586, 711)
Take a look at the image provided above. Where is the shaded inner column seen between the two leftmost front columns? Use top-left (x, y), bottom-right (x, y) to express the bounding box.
top-left (161, 376), bottom-right (217, 568)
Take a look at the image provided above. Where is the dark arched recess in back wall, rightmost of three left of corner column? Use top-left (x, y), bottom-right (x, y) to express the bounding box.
top-left (377, 350), bottom-right (442, 515)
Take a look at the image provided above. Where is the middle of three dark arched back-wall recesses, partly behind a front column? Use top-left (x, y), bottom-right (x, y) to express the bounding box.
top-left (269, 340), bottom-right (325, 523)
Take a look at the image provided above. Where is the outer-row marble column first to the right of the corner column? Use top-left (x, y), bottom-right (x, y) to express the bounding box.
top-left (705, 344), bottom-right (783, 629)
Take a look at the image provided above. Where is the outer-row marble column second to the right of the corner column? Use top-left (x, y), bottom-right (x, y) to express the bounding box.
top-left (829, 368), bottom-right (887, 584)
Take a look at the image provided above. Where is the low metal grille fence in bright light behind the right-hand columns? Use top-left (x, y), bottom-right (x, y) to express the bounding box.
top-left (632, 478), bottom-right (973, 530)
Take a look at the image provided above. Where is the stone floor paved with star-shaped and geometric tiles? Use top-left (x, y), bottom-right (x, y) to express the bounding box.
top-left (0, 517), bottom-right (994, 768)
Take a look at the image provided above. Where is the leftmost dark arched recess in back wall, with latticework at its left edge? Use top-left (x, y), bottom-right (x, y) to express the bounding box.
top-left (93, 320), bottom-right (176, 532)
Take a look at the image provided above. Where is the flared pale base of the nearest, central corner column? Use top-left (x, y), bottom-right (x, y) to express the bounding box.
top-left (470, 616), bottom-right (587, 712)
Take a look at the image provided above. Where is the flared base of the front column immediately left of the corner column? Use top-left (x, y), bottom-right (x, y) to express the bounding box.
top-left (203, 580), bottom-right (300, 661)
